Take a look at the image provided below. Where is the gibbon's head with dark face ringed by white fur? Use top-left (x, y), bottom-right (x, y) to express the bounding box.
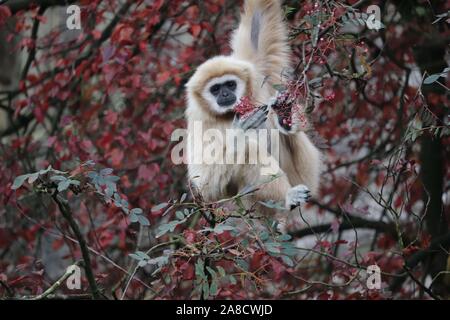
top-left (186, 56), bottom-right (254, 115)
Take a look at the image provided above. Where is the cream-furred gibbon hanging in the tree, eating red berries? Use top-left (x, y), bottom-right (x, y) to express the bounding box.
top-left (186, 0), bottom-right (322, 213)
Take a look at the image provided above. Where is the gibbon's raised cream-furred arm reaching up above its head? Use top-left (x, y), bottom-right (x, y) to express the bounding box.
top-left (231, 0), bottom-right (291, 91)
